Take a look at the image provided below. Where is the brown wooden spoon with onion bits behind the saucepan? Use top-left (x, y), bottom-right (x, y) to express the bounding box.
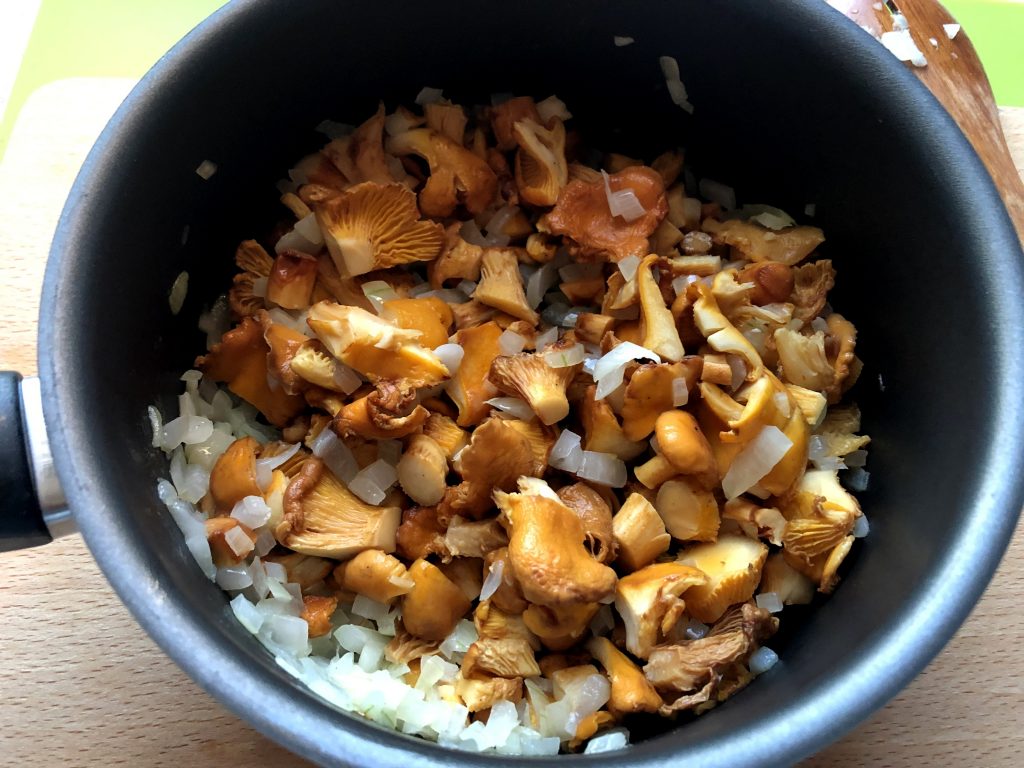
top-left (828, 0), bottom-right (1024, 243)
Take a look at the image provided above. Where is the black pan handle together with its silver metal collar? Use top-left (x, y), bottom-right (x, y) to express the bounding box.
top-left (0, 371), bottom-right (75, 552)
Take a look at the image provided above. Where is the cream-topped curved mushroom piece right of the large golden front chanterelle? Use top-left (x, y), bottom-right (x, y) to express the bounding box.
top-left (678, 536), bottom-right (768, 624)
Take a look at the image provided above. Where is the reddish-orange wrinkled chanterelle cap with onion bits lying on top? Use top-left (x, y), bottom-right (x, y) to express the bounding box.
top-left (540, 166), bottom-right (669, 261)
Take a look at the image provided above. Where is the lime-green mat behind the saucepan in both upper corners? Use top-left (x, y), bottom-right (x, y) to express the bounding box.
top-left (0, 0), bottom-right (1024, 159)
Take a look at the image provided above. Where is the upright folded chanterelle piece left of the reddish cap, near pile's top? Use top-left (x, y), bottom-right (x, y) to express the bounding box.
top-left (512, 119), bottom-right (569, 207)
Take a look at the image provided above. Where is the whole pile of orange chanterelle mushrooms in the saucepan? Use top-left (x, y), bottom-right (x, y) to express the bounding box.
top-left (190, 97), bottom-right (868, 745)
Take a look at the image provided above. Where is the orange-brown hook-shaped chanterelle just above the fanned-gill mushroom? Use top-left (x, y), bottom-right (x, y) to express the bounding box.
top-left (387, 128), bottom-right (498, 218)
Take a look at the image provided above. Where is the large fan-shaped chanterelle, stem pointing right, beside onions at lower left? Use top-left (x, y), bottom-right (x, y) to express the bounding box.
top-left (273, 458), bottom-right (401, 560)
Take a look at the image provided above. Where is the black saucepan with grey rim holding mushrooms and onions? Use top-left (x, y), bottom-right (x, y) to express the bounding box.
top-left (0, 0), bottom-right (1024, 768)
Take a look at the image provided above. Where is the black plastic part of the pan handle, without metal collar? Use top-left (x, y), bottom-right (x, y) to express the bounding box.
top-left (0, 371), bottom-right (52, 552)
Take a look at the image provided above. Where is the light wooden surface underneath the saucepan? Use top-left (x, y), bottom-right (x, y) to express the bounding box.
top-left (0, 81), bottom-right (1024, 768)
